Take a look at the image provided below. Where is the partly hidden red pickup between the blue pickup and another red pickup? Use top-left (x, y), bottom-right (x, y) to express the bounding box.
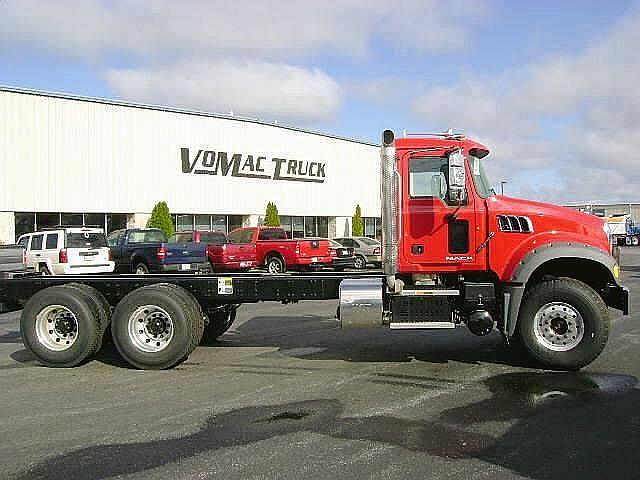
top-left (172, 230), bottom-right (257, 272)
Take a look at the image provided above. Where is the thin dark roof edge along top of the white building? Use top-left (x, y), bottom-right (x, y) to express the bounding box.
top-left (0, 85), bottom-right (380, 147)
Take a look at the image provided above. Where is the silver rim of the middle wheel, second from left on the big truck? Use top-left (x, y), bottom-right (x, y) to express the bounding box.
top-left (128, 305), bottom-right (174, 353)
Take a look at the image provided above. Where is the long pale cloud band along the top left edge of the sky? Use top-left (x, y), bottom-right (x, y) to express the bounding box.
top-left (0, 0), bottom-right (486, 59)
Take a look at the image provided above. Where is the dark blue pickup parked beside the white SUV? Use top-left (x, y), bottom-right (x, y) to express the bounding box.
top-left (107, 228), bottom-right (210, 275)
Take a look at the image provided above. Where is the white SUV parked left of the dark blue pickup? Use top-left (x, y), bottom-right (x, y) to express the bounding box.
top-left (17, 227), bottom-right (115, 275)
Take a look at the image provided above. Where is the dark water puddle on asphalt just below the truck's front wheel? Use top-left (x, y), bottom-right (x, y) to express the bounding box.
top-left (442, 372), bottom-right (638, 424)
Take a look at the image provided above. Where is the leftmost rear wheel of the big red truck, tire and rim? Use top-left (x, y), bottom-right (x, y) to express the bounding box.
top-left (20, 285), bottom-right (102, 367)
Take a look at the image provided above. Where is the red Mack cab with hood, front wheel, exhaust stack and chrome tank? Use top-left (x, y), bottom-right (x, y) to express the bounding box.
top-left (339, 130), bottom-right (629, 369)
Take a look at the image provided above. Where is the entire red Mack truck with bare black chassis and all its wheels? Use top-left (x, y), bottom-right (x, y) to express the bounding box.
top-left (0, 130), bottom-right (629, 370)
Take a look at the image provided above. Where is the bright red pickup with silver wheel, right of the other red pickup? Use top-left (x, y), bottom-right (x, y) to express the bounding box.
top-left (229, 227), bottom-right (332, 273)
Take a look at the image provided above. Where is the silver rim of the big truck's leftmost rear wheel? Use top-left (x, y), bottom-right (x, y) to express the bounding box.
top-left (36, 305), bottom-right (78, 352)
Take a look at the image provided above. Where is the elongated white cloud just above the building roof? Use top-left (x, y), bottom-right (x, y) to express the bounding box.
top-left (106, 59), bottom-right (341, 123)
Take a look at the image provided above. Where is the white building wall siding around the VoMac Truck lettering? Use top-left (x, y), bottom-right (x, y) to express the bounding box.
top-left (0, 91), bottom-right (380, 216)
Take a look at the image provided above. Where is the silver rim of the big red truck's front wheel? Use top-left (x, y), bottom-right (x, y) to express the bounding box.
top-left (534, 302), bottom-right (584, 352)
